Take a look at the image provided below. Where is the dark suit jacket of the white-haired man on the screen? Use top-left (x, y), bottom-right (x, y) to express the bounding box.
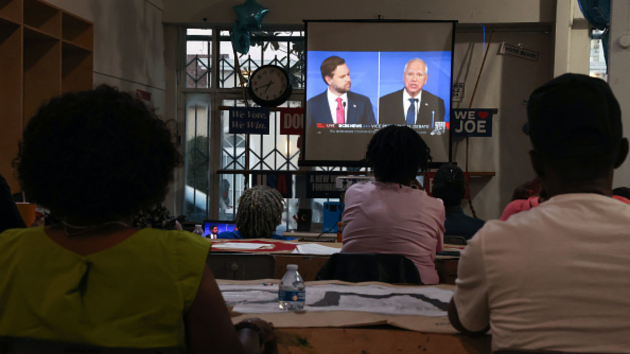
top-left (378, 88), bottom-right (444, 128)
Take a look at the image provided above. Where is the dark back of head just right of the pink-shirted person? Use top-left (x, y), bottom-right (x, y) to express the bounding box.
top-left (432, 164), bottom-right (466, 206)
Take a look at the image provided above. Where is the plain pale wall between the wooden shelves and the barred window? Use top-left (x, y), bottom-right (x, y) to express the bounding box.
top-left (48, 0), bottom-right (165, 114)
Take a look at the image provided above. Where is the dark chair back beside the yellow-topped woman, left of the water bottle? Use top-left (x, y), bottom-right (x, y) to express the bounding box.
top-left (206, 252), bottom-right (276, 280)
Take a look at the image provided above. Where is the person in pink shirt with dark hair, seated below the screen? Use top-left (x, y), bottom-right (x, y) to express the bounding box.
top-left (341, 125), bottom-right (445, 284)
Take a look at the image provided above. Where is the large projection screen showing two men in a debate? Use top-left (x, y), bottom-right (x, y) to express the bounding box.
top-left (300, 20), bottom-right (456, 166)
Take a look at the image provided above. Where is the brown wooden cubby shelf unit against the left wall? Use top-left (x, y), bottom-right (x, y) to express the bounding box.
top-left (0, 0), bottom-right (94, 193)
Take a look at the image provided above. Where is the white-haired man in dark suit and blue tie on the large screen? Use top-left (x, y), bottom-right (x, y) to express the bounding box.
top-left (378, 58), bottom-right (444, 129)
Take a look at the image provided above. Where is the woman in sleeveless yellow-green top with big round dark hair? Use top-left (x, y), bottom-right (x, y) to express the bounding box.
top-left (0, 86), bottom-right (274, 353)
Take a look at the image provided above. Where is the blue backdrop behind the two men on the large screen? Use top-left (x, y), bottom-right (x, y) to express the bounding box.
top-left (306, 51), bottom-right (451, 122)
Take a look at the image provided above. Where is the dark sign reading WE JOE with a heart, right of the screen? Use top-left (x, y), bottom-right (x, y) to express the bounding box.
top-left (451, 109), bottom-right (494, 137)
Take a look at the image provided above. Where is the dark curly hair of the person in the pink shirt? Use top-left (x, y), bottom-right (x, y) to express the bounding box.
top-left (365, 125), bottom-right (432, 185)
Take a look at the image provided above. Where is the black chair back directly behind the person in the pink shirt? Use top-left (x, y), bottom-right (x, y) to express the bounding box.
top-left (315, 253), bottom-right (422, 285)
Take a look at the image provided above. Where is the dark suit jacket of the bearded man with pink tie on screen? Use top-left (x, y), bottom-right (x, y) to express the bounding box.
top-left (306, 91), bottom-right (376, 127)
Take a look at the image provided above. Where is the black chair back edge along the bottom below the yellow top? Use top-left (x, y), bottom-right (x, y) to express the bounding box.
top-left (0, 337), bottom-right (180, 354)
